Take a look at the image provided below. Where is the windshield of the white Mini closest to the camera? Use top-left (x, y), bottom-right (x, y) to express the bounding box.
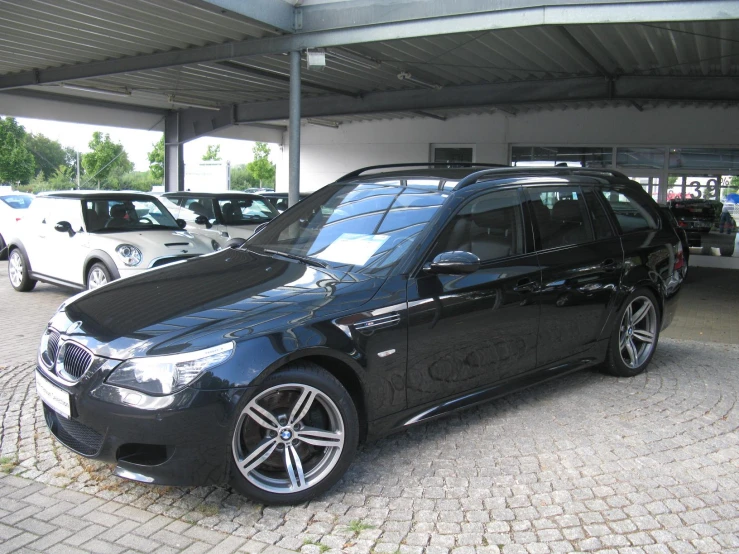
top-left (82, 197), bottom-right (180, 233)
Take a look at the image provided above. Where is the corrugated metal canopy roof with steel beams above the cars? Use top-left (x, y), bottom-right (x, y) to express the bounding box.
top-left (0, 0), bottom-right (739, 133)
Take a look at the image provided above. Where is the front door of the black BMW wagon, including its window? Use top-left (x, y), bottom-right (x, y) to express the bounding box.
top-left (407, 189), bottom-right (540, 406)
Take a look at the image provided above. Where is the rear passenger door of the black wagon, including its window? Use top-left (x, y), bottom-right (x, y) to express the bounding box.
top-left (526, 185), bottom-right (623, 367)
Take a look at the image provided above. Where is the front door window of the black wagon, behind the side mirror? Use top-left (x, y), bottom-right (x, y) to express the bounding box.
top-left (433, 190), bottom-right (525, 262)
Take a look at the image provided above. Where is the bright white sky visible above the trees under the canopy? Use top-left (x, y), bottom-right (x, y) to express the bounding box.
top-left (16, 117), bottom-right (266, 171)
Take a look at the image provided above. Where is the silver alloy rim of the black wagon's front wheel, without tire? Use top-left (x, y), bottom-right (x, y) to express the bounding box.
top-left (232, 383), bottom-right (344, 494)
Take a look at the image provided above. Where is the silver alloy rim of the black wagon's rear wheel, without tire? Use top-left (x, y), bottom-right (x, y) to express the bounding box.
top-left (618, 296), bottom-right (657, 369)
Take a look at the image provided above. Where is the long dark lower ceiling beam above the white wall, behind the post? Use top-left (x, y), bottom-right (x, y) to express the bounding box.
top-left (228, 76), bottom-right (739, 123)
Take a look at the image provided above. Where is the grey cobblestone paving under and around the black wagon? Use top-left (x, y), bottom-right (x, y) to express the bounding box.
top-left (0, 339), bottom-right (739, 554)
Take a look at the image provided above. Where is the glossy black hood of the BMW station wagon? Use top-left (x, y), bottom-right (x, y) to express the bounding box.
top-left (51, 249), bottom-right (384, 359)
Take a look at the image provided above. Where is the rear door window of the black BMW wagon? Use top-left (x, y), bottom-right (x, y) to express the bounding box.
top-left (527, 187), bottom-right (594, 250)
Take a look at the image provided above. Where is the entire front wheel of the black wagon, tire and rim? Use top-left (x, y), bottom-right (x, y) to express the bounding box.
top-left (230, 362), bottom-right (359, 504)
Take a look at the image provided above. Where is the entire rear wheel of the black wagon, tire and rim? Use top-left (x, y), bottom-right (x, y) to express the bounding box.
top-left (604, 288), bottom-right (661, 377)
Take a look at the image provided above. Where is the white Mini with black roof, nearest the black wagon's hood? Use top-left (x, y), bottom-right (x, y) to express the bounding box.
top-left (8, 191), bottom-right (214, 292)
